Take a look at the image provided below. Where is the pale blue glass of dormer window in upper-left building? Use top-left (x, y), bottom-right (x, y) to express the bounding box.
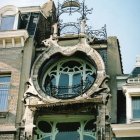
top-left (0, 16), bottom-right (15, 30)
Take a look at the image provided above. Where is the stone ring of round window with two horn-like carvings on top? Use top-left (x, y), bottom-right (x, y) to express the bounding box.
top-left (30, 36), bottom-right (107, 103)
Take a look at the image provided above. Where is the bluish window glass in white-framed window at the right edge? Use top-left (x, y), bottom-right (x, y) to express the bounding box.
top-left (132, 97), bottom-right (140, 119)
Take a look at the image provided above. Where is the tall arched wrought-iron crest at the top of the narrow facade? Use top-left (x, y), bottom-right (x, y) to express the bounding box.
top-left (57, 0), bottom-right (92, 35)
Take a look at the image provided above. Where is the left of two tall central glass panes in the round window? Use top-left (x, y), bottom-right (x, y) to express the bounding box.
top-left (58, 73), bottom-right (69, 96)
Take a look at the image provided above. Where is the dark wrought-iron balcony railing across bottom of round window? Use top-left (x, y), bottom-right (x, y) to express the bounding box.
top-left (46, 79), bottom-right (92, 99)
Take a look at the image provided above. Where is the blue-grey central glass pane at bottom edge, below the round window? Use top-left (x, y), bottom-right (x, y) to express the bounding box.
top-left (55, 131), bottom-right (80, 140)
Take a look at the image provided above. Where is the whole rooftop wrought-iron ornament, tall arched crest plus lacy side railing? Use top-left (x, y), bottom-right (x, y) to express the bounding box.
top-left (57, 0), bottom-right (107, 40)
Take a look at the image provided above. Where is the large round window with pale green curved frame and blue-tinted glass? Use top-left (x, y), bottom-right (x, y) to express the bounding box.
top-left (39, 53), bottom-right (96, 99)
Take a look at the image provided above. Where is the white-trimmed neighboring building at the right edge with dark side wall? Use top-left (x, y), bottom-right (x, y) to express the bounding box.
top-left (112, 57), bottom-right (140, 140)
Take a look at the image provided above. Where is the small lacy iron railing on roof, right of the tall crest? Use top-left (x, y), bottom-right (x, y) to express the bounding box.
top-left (86, 25), bottom-right (107, 43)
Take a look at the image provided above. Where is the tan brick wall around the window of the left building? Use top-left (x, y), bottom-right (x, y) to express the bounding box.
top-left (0, 47), bottom-right (22, 127)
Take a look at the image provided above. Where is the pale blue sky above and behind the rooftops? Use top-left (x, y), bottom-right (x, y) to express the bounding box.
top-left (0, 0), bottom-right (140, 74)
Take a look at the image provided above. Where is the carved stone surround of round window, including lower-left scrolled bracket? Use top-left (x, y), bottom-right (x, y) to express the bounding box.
top-left (24, 37), bottom-right (107, 105)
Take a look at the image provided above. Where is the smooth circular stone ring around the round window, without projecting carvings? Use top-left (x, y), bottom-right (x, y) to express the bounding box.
top-left (31, 44), bottom-right (106, 103)
